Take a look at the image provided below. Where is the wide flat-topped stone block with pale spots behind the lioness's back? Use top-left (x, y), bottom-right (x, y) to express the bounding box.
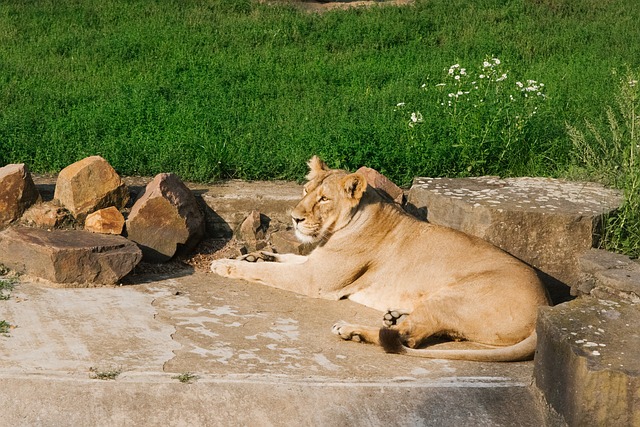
top-left (407, 177), bottom-right (622, 286)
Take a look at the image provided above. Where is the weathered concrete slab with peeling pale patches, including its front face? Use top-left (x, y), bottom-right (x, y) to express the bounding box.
top-left (0, 270), bottom-right (554, 426)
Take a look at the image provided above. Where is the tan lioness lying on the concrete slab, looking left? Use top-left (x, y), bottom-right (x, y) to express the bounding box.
top-left (211, 156), bottom-right (549, 361)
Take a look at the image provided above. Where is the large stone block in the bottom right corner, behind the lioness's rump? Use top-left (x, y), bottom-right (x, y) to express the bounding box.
top-left (534, 296), bottom-right (640, 426)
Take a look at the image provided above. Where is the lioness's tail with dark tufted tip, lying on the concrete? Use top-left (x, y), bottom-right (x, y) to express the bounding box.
top-left (379, 328), bottom-right (537, 362)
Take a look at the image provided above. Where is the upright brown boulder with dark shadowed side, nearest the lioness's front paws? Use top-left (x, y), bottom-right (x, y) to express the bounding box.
top-left (127, 173), bottom-right (205, 262)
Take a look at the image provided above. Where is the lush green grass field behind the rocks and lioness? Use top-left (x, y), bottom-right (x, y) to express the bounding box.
top-left (0, 0), bottom-right (640, 254)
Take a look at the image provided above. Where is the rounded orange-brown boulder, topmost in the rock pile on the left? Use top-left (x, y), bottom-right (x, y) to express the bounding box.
top-left (54, 156), bottom-right (129, 222)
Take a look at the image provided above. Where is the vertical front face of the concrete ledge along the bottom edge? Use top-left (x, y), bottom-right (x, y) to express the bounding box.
top-left (0, 376), bottom-right (545, 427)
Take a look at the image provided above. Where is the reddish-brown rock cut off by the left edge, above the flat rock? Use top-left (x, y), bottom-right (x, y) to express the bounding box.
top-left (0, 163), bottom-right (41, 229)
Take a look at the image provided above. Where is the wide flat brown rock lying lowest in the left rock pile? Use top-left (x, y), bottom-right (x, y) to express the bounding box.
top-left (0, 227), bottom-right (142, 287)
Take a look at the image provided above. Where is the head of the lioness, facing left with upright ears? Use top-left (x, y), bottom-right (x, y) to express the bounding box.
top-left (291, 156), bottom-right (367, 243)
